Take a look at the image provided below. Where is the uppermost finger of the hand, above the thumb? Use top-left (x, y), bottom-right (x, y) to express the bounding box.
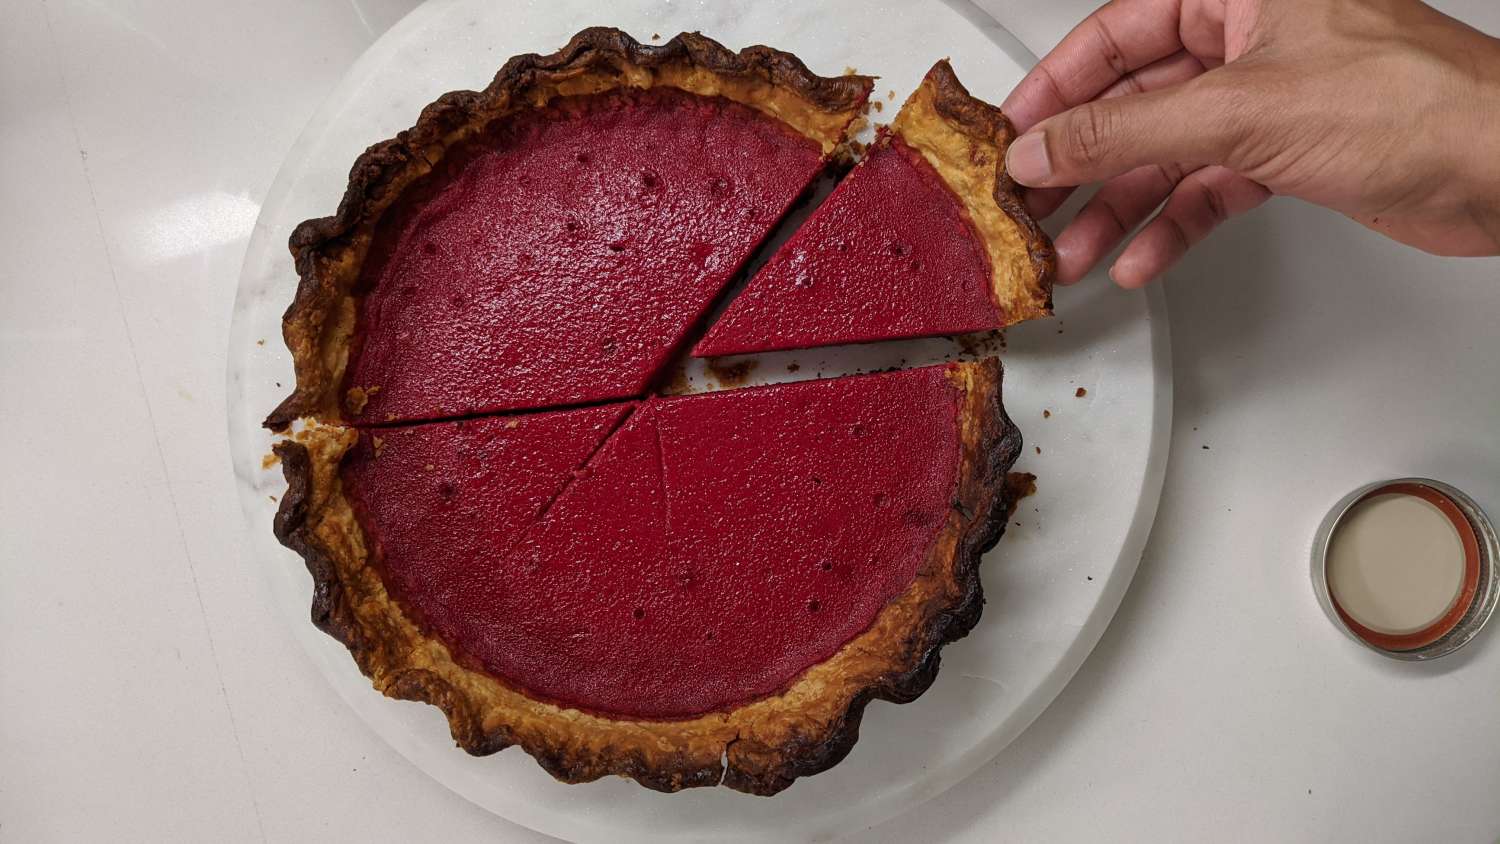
top-left (1001, 0), bottom-right (1182, 132)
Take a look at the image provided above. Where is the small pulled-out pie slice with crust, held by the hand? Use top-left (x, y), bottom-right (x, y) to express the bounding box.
top-left (693, 61), bottom-right (1055, 357)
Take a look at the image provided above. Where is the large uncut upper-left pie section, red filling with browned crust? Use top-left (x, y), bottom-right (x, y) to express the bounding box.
top-left (267, 28), bottom-right (872, 430)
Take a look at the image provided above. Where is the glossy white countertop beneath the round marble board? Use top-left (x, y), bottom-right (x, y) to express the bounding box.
top-left (0, 0), bottom-right (1500, 843)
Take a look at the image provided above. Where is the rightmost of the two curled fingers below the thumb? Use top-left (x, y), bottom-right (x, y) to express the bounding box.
top-left (1110, 166), bottom-right (1271, 288)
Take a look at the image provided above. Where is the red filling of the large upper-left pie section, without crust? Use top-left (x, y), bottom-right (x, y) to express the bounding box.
top-left (345, 88), bottom-right (824, 423)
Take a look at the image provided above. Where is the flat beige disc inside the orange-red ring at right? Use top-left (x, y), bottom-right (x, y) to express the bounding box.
top-left (1328, 493), bottom-right (1464, 636)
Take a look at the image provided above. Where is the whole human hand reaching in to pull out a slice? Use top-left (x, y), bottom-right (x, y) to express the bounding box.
top-left (1002, 0), bottom-right (1500, 288)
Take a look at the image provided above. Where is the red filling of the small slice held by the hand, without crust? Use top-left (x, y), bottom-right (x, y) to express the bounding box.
top-left (693, 135), bottom-right (1001, 357)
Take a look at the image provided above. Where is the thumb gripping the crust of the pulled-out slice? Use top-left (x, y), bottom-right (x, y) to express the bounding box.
top-left (1005, 70), bottom-right (1253, 187)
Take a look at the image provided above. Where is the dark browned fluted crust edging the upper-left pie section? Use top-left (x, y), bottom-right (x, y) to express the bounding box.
top-left (266, 27), bottom-right (875, 430)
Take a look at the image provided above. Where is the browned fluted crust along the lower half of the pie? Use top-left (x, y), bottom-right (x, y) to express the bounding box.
top-left (276, 358), bottom-right (1022, 795)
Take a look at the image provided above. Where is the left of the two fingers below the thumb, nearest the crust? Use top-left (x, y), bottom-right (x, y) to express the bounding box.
top-left (1053, 165), bottom-right (1184, 285)
